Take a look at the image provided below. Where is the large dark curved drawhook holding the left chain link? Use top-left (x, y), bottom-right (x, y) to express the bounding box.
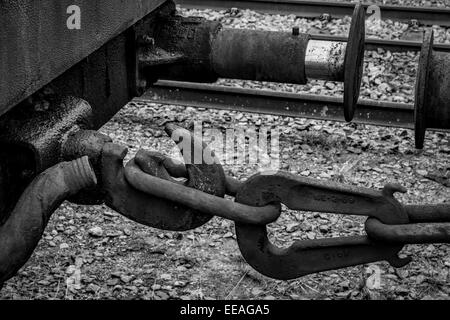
top-left (102, 123), bottom-right (229, 231)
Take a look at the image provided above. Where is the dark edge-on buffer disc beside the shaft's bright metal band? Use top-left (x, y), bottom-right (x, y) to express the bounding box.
top-left (344, 3), bottom-right (366, 122)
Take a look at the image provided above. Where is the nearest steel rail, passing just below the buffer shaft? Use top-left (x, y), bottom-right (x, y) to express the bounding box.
top-left (138, 81), bottom-right (414, 129)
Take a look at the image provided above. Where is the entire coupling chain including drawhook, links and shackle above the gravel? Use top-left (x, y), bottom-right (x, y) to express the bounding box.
top-left (96, 125), bottom-right (450, 280)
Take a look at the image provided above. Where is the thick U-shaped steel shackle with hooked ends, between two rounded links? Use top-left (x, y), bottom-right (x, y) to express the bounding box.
top-left (236, 173), bottom-right (410, 280)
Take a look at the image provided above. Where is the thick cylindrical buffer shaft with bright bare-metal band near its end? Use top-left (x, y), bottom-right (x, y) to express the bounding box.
top-left (149, 16), bottom-right (347, 84)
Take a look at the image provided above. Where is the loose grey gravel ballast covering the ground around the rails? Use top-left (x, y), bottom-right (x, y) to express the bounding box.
top-left (0, 1), bottom-right (450, 300)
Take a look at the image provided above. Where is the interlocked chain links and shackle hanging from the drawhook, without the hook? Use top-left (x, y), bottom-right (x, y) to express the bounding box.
top-left (116, 125), bottom-right (450, 279)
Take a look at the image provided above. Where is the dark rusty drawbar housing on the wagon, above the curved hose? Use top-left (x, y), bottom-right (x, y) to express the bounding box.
top-left (0, 96), bottom-right (92, 224)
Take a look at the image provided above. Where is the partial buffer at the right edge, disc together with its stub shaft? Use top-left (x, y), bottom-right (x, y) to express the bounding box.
top-left (414, 29), bottom-right (450, 149)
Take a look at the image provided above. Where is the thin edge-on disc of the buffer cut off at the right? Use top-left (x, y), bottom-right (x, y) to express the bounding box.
top-left (414, 29), bottom-right (434, 149)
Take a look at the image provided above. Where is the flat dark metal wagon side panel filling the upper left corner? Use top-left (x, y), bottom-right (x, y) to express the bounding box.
top-left (0, 0), bottom-right (166, 115)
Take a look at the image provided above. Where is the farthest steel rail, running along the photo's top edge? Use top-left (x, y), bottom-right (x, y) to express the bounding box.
top-left (175, 0), bottom-right (450, 27)
